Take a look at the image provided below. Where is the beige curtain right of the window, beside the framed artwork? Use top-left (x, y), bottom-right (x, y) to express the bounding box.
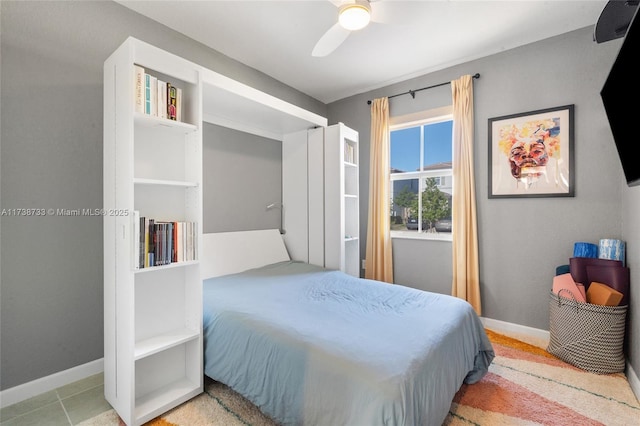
top-left (451, 75), bottom-right (482, 315)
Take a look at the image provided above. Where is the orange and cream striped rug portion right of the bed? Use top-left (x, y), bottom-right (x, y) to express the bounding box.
top-left (444, 330), bottom-right (640, 426)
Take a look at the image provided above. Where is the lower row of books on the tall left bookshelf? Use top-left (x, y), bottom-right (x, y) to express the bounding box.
top-left (133, 211), bottom-right (198, 269)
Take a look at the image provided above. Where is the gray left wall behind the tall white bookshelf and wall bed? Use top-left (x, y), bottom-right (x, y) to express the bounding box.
top-left (0, 1), bottom-right (326, 389)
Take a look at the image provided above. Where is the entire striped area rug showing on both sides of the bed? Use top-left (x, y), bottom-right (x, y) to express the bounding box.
top-left (82, 330), bottom-right (640, 426)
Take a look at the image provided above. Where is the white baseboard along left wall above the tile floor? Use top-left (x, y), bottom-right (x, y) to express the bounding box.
top-left (0, 358), bottom-right (104, 408)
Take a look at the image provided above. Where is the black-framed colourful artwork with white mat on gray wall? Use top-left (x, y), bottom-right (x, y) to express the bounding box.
top-left (489, 105), bottom-right (574, 198)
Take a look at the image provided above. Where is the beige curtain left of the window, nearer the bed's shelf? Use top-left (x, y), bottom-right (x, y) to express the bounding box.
top-left (364, 98), bottom-right (393, 283)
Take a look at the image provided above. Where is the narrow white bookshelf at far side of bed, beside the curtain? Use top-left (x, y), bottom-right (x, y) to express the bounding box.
top-left (324, 123), bottom-right (360, 277)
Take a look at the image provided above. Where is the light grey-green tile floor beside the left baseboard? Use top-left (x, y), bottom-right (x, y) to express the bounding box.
top-left (0, 373), bottom-right (111, 426)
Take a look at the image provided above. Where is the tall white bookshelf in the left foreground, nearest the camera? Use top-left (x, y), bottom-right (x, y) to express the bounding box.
top-left (104, 38), bottom-right (203, 425)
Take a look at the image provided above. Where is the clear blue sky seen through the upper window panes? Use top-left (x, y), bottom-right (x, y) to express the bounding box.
top-left (391, 121), bottom-right (453, 172)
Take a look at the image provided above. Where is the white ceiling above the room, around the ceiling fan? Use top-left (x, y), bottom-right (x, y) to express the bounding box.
top-left (116, 0), bottom-right (607, 103)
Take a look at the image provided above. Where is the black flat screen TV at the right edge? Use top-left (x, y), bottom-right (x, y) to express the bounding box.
top-left (600, 3), bottom-right (640, 186)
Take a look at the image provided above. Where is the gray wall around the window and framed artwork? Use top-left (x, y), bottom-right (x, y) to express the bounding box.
top-left (328, 28), bottom-right (640, 372)
